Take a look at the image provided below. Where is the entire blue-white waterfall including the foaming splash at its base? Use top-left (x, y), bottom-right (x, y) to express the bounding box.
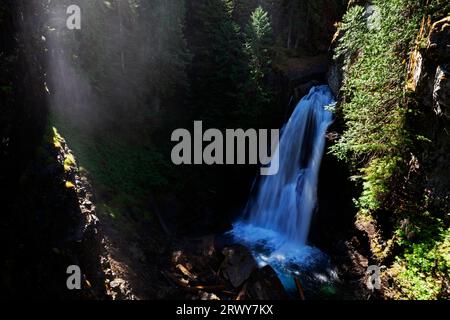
top-left (231, 86), bottom-right (335, 292)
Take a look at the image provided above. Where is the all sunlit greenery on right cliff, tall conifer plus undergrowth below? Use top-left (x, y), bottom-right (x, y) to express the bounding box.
top-left (332, 0), bottom-right (450, 299)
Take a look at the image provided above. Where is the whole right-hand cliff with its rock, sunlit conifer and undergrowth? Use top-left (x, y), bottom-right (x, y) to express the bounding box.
top-left (329, 0), bottom-right (450, 299)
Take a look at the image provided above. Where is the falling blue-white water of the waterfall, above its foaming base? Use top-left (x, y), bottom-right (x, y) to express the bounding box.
top-left (239, 86), bottom-right (334, 245)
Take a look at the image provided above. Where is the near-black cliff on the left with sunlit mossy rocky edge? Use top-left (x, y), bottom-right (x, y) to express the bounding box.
top-left (0, 0), bottom-right (112, 299)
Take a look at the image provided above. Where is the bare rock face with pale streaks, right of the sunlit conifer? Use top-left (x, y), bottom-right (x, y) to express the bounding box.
top-left (408, 17), bottom-right (450, 201)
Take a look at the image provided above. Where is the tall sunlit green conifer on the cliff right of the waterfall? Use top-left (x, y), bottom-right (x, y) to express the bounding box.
top-left (332, 0), bottom-right (422, 215)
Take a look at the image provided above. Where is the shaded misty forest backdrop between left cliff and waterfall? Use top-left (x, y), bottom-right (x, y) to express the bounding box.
top-left (45, 0), bottom-right (273, 235)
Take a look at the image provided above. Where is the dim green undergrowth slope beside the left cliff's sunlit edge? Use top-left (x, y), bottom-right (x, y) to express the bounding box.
top-left (48, 120), bottom-right (170, 225)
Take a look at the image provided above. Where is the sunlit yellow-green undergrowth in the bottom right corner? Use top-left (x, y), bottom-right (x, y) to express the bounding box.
top-left (388, 211), bottom-right (450, 300)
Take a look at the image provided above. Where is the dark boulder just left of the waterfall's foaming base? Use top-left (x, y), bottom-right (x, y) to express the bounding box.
top-left (221, 245), bottom-right (258, 288)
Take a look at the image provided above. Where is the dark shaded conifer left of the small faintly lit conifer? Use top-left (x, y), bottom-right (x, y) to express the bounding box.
top-left (187, 0), bottom-right (246, 127)
